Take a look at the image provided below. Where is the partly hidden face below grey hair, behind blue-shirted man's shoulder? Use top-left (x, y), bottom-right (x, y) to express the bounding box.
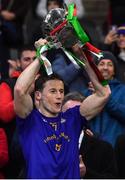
top-left (62, 100), bottom-right (81, 112)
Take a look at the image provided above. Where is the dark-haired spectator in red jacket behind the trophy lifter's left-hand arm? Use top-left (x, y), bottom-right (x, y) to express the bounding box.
top-left (0, 47), bottom-right (36, 122)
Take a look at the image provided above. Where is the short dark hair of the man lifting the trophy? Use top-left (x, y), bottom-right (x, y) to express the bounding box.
top-left (35, 74), bottom-right (64, 91)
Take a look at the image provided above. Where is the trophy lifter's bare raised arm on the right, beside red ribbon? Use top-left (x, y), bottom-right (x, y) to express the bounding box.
top-left (73, 44), bottom-right (111, 120)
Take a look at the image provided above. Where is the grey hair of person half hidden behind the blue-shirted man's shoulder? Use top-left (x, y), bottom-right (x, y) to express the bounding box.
top-left (63, 91), bottom-right (85, 105)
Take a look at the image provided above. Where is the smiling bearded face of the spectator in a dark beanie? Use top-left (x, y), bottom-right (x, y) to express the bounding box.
top-left (98, 59), bottom-right (115, 80)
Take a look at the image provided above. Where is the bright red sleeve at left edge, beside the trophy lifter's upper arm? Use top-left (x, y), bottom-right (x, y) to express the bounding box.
top-left (0, 82), bottom-right (15, 123)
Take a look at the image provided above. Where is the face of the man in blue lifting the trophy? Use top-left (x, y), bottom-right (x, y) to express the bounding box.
top-left (39, 80), bottom-right (64, 117)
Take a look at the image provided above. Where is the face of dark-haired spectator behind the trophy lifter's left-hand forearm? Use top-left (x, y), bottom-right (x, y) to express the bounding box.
top-left (20, 50), bottom-right (36, 70)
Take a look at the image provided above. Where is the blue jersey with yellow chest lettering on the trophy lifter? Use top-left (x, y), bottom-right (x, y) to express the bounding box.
top-left (17, 106), bottom-right (86, 179)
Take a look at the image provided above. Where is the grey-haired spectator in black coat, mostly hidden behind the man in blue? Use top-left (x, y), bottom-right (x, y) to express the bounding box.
top-left (62, 92), bottom-right (117, 179)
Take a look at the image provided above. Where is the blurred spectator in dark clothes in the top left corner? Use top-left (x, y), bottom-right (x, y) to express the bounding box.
top-left (0, 0), bottom-right (29, 78)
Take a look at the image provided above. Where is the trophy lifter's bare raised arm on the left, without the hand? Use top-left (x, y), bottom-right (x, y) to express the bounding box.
top-left (14, 59), bottom-right (40, 118)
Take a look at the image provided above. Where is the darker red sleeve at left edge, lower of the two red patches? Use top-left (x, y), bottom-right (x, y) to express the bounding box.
top-left (0, 128), bottom-right (9, 168)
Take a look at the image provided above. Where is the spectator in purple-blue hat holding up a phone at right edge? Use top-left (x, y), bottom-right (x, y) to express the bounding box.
top-left (104, 24), bottom-right (125, 83)
